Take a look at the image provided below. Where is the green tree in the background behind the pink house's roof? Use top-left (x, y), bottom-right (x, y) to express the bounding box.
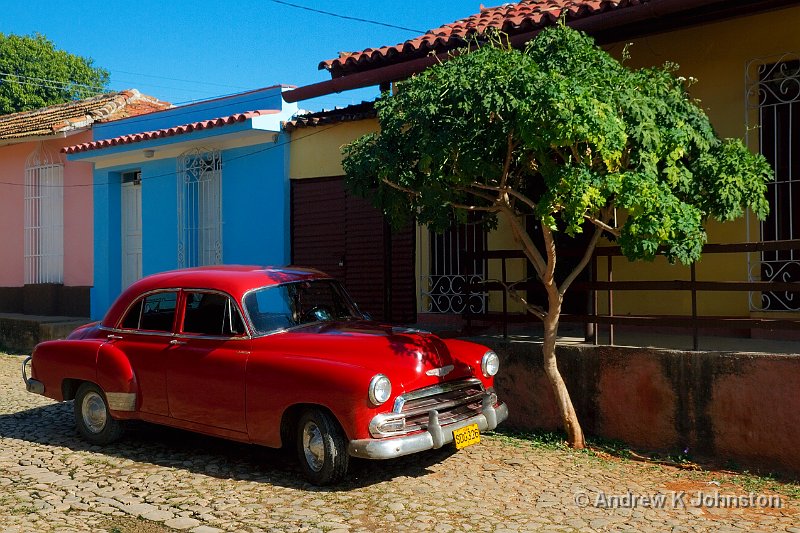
top-left (0, 33), bottom-right (109, 115)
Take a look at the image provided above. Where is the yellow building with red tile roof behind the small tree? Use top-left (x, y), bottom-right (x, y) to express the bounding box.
top-left (286, 0), bottom-right (800, 331)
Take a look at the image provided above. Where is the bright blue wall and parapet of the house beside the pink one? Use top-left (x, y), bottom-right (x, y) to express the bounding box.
top-left (77, 86), bottom-right (297, 319)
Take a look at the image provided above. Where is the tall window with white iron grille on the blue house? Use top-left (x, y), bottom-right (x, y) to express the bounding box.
top-left (178, 149), bottom-right (222, 267)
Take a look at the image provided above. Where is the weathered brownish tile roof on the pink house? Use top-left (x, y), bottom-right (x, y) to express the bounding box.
top-left (0, 89), bottom-right (172, 142)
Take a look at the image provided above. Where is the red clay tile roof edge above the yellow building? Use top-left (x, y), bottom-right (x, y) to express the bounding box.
top-left (319, 0), bottom-right (649, 77)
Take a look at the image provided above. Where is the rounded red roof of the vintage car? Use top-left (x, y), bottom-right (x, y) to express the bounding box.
top-left (103, 265), bottom-right (330, 327)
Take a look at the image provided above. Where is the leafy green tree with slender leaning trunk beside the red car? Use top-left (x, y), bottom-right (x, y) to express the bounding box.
top-left (343, 25), bottom-right (772, 448)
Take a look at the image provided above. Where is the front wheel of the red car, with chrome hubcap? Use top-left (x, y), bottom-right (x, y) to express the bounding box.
top-left (297, 409), bottom-right (350, 485)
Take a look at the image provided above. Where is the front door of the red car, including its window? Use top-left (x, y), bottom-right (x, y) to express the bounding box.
top-left (166, 290), bottom-right (250, 433)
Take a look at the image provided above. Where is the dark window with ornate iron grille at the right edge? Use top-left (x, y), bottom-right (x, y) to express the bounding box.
top-left (746, 53), bottom-right (800, 311)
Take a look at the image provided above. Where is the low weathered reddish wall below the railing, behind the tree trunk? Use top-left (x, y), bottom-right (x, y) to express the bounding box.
top-left (488, 339), bottom-right (800, 475)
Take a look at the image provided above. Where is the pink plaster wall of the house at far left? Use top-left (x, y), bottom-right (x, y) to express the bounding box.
top-left (0, 131), bottom-right (94, 287)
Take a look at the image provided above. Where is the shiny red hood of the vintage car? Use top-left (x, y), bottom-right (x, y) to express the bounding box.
top-left (254, 321), bottom-right (482, 392)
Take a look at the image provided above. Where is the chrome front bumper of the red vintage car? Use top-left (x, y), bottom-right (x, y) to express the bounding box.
top-left (347, 403), bottom-right (508, 459)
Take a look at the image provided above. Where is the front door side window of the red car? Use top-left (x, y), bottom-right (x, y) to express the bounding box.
top-left (182, 291), bottom-right (245, 337)
